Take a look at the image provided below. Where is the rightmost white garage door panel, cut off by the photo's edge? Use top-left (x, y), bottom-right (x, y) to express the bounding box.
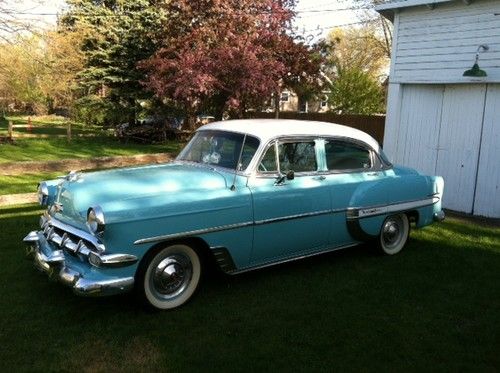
top-left (474, 84), bottom-right (500, 218)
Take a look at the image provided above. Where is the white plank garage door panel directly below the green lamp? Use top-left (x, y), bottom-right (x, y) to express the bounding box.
top-left (436, 84), bottom-right (486, 213)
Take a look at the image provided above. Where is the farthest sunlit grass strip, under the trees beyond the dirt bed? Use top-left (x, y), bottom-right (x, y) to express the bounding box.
top-left (0, 117), bottom-right (182, 163)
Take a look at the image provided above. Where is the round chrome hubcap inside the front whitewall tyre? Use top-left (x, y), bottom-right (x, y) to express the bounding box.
top-left (152, 254), bottom-right (193, 299)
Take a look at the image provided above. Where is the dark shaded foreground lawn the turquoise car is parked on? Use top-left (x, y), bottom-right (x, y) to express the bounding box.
top-left (0, 206), bottom-right (500, 372)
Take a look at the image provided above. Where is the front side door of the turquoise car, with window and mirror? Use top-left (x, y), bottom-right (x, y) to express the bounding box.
top-left (248, 138), bottom-right (331, 265)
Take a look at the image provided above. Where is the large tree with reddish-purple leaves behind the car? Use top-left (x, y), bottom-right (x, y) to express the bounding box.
top-left (141, 0), bottom-right (322, 126)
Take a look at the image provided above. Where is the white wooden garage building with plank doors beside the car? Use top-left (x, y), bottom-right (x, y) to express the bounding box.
top-left (376, 0), bottom-right (500, 218)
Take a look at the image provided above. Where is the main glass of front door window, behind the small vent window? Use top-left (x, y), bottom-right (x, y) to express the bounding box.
top-left (278, 141), bottom-right (318, 173)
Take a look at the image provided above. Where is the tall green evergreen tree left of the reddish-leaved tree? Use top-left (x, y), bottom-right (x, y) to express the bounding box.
top-left (61, 0), bottom-right (165, 122)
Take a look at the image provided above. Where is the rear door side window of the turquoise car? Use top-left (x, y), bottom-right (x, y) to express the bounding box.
top-left (325, 140), bottom-right (372, 171)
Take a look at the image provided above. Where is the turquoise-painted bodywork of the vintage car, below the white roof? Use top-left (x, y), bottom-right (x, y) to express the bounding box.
top-left (33, 134), bottom-right (443, 288)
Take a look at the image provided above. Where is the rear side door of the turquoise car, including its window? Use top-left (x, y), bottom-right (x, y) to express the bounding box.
top-left (324, 138), bottom-right (385, 247)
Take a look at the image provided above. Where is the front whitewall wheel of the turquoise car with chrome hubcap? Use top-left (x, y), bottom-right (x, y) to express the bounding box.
top-left (140, 244), bottom-right (201, 310)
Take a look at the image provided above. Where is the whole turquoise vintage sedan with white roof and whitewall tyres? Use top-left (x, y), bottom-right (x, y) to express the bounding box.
top-left (24, 120), bottom-right (444, 309)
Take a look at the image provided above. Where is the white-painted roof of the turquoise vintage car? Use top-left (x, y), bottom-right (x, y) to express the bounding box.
top-left (198, 119), bottom-right (380, 151)
